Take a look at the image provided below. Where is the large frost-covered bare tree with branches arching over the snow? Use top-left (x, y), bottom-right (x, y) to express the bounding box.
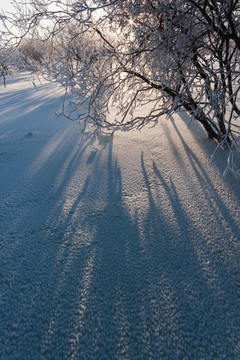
top-left (0, 0), bottom-right (240, 174)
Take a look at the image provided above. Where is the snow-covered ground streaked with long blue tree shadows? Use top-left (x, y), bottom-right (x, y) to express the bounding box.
top-left (0, 73), bottom-right (240, 360)
